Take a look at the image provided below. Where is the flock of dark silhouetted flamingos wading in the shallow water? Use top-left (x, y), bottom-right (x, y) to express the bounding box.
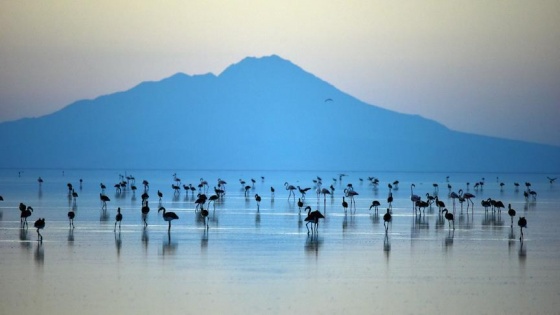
top-left (0, 174), bottom-right (556, 242)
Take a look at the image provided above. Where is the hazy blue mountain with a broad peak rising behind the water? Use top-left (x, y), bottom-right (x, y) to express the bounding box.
top-left (0, 55), bottom-right (560, 172)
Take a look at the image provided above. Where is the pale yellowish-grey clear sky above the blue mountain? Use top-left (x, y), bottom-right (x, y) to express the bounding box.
top-left (0, 0), bottom-right (560, 146)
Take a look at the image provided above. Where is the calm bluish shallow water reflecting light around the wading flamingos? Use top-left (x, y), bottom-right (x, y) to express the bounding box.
top-left (0, 170), bottom-right (560, 314)
